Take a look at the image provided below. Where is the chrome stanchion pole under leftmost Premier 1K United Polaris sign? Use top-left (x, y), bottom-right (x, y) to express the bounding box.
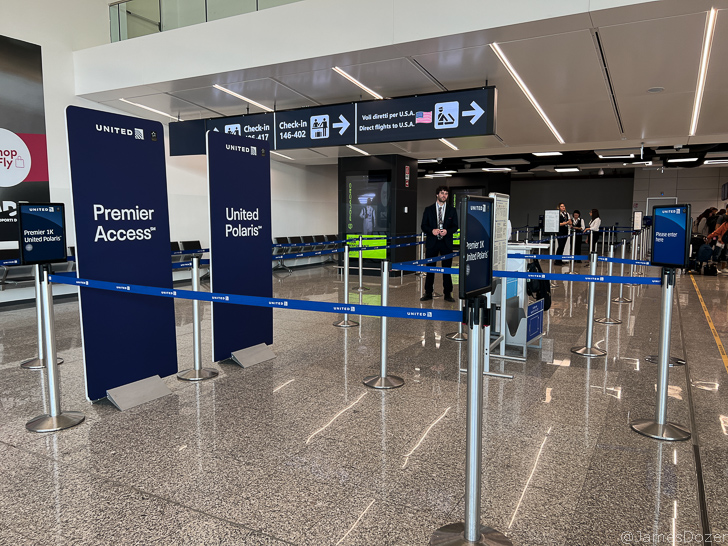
top-left (25, 271), bottom-right (86, 432)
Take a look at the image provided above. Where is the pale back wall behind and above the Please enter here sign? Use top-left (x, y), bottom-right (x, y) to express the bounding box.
top-left (633, 167), bottom-right (728, 218)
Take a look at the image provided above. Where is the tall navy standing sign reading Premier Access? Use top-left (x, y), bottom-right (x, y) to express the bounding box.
top-left (66, 106), bottom-right (177, 400)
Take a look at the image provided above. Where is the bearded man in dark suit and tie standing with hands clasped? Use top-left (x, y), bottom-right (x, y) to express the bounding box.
top-left (420, 186), bottom-right (458, 301)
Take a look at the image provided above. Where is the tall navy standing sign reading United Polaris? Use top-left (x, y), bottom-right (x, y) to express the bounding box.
top-left (207, 131), bottom-right (273, 362)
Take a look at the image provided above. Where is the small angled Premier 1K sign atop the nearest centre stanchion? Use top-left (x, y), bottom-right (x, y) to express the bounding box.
top-left (460, 195), bottom-right (493, 299)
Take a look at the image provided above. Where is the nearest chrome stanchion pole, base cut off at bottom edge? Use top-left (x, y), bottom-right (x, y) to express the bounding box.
top-left (430, 299), bottom-right (512, 546)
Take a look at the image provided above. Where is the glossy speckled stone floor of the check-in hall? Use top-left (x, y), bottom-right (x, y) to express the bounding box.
top-left (0, 266), bottom-right (728, 546)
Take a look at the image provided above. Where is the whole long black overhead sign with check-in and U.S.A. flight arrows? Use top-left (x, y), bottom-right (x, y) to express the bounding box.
top-left (170, 87), bottom-right (497, 155)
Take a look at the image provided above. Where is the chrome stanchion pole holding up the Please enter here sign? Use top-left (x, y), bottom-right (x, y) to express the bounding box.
top-left (630, 268), bottom-right (690, 441)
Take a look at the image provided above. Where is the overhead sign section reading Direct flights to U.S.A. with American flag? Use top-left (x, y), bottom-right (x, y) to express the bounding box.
top-left (356, 87), bottom-right (496, 144)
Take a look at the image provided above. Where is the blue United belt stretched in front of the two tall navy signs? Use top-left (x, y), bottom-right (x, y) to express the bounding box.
top-left (49, 275), bottom-right (463, 322)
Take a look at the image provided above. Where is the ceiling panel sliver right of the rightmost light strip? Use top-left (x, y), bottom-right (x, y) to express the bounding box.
top-left (696, 10), bottom-right (728, 136)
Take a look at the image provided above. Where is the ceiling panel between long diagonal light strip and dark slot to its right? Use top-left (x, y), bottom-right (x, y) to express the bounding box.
top-left (499, 30), bottom-right (622, 142)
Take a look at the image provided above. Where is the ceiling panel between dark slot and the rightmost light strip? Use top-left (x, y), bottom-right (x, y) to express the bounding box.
top-left (599, 13), bottom-right (706, 139)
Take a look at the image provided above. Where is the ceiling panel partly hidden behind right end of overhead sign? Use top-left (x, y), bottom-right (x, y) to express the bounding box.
top-left (415, 46), bottom-right (558, 146)
